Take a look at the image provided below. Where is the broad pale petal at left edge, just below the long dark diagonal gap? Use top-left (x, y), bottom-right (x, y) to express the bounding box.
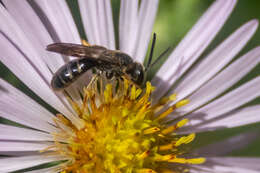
top-left (0, 80), bottom-right (55, 132)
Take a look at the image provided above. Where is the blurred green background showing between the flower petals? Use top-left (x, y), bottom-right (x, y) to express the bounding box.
top-left (0, 0), bottom-right (260, 156)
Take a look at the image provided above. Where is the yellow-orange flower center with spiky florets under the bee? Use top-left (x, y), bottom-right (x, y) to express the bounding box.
top-left (46, 80), bottom-right (205, 173)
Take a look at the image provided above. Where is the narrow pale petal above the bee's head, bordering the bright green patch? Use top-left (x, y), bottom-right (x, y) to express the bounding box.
top-left (132, 0), bottom-right (159, 63)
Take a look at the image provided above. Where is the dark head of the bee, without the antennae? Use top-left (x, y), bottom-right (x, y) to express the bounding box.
top-left (125, 62), bottom-right (145, 86)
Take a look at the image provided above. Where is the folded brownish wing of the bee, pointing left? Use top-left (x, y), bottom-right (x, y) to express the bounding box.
top-left (46, 43), bottom-right (107, 58)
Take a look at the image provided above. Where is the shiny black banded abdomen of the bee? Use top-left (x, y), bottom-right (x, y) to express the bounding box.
top-left (51, 58), bottom-right (96, 90)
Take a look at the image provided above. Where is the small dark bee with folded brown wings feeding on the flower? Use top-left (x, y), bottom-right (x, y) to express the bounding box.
top-left (46, 34), bottom-right (169, 90)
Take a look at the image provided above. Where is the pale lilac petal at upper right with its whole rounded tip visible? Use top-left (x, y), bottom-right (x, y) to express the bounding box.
top-left (171, 20), bottom-right (258, 101)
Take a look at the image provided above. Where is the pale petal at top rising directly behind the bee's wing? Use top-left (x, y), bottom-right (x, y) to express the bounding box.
top-left (79, 0), bottom-right (115, 49)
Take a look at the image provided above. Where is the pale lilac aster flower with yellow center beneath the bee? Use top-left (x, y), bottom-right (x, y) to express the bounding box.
top-left (0, 0), bottom-right (260, 173)
